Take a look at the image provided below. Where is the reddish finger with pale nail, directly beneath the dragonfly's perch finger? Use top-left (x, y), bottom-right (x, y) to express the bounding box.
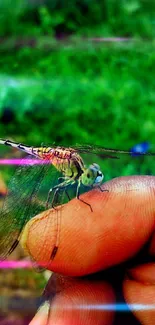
top-left (30, 274), bottom-right (115, 325)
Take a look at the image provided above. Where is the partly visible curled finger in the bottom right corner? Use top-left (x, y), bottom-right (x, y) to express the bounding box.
top-left (123, 263), bottom-right (155, 325)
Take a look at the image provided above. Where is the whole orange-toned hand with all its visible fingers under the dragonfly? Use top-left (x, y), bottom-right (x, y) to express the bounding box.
top-left (22, 176), bottom-right (155, 325)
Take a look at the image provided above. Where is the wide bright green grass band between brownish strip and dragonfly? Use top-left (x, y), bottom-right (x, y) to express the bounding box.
top-left (0, 45), bottom-right (155, 148)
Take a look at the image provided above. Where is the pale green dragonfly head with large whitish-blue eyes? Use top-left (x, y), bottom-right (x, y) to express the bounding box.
top-left (81, 163), bottom-right (104, 186)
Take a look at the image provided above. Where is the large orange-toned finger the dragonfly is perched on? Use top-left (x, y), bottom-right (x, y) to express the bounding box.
top-left (22, 176), bottom-right (155, 276)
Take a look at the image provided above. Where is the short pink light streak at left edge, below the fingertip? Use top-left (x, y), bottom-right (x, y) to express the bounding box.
top-left (0, 260), bottom-right (32, 269)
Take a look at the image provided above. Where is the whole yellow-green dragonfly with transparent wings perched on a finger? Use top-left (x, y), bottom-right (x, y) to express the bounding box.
top-left (0, 139), bottom-right (155, 266)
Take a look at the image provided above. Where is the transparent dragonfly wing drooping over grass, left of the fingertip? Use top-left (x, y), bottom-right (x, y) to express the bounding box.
top-left (0, 156), bottom-right (62, 259)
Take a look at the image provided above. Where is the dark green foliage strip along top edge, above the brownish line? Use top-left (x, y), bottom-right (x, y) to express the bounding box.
top-left (0, 0), bottom-right (155, 38)
